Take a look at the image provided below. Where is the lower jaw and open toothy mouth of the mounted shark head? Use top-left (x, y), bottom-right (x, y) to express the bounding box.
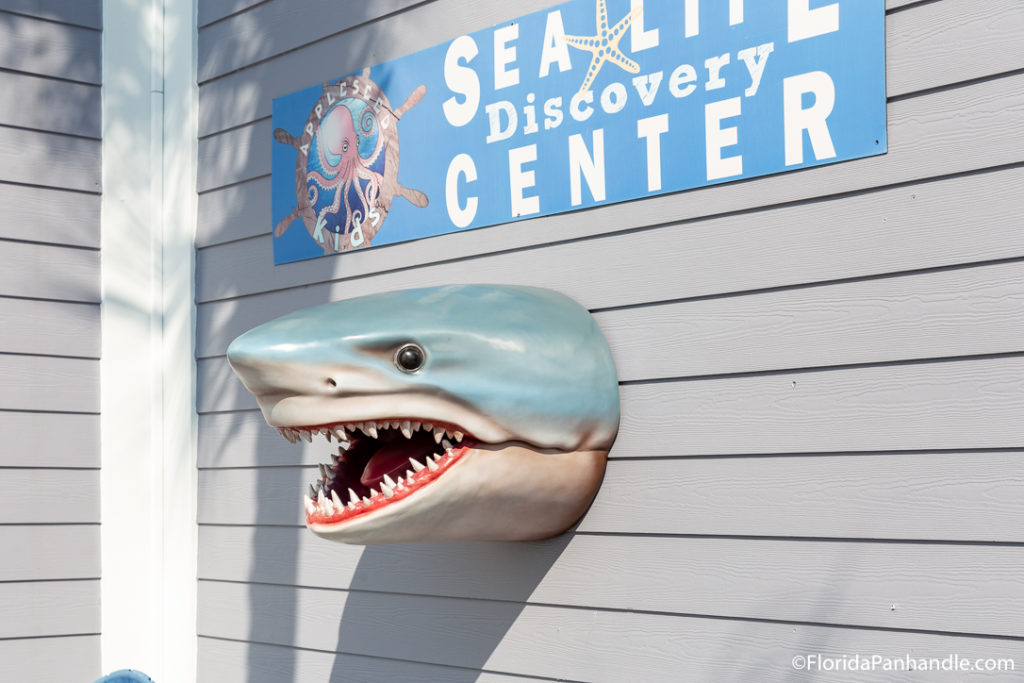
top-left (276, 418), bottom-right (607, 545)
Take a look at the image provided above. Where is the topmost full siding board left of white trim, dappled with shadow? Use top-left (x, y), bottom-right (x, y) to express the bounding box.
top-left (0, 9), bottom-right (101, 82)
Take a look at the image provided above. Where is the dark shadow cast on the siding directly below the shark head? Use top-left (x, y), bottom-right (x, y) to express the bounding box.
top-left (325, 531), bottom-right (573, 683)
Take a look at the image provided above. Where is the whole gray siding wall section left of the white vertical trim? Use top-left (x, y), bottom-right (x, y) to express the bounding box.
top-left (0, 0), bottom-right (101, 671)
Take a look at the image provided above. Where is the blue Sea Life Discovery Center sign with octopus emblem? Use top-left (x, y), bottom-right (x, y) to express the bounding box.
top-left (272, 0), bottom-right (886, 263)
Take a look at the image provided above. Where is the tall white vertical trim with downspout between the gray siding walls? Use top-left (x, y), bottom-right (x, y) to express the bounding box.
top-left (100, 0), bottom-right (198, 683)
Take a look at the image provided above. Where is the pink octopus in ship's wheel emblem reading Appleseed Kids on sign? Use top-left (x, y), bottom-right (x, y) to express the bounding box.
top-left (273, 69), bottom-right (428, 254)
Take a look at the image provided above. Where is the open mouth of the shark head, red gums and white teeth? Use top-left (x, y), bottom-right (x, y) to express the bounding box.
top-left (278, 418), bottom-right (477, 525)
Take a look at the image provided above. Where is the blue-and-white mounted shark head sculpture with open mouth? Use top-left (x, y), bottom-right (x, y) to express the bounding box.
top-left (227, 285), bottom-right (618, 545)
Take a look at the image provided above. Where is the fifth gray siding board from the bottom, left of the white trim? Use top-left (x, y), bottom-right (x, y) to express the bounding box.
top-left (0, 411), bottom-right (99, 471)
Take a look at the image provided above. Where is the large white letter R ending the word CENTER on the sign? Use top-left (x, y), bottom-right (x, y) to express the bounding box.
top-left (782, 71), bottom-right (836, 166)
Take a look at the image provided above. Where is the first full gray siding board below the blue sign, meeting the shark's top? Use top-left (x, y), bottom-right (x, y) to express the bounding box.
top-left (198, 168), bottom-right (1024, 359)
